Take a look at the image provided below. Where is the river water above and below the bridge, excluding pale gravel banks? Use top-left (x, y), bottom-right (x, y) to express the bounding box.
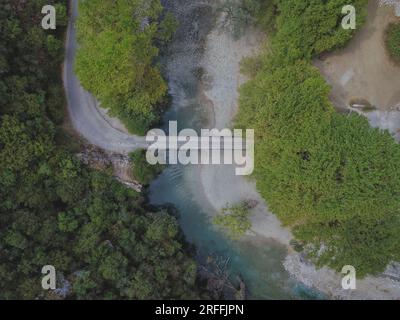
top-left (149, 0), bottom-right (322, 299)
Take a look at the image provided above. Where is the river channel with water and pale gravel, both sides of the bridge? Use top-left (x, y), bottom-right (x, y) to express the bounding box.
top-left (149, 0), bottom-right (322, 299)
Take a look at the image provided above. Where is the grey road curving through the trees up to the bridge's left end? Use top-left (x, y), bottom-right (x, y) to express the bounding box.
top-left (63, 0), bottom-right (148, 154)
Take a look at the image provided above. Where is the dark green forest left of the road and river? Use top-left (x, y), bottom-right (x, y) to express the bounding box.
top-left (0, 0), bottom-right (197, 299)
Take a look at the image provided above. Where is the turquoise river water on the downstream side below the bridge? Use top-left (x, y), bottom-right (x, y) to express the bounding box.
top-left (150, 165), bottom-right (322, 299)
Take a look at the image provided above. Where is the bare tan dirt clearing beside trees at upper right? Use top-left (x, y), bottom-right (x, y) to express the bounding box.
top-left (315, 0), bottom-right (400, 111)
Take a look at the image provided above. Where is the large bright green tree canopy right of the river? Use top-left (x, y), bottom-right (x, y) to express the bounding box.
top-left (236, 0), bottom-right (400, 276)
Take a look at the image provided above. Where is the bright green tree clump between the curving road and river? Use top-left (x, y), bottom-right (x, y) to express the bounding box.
top-left (75, 0), bottom-right (175, 135)
